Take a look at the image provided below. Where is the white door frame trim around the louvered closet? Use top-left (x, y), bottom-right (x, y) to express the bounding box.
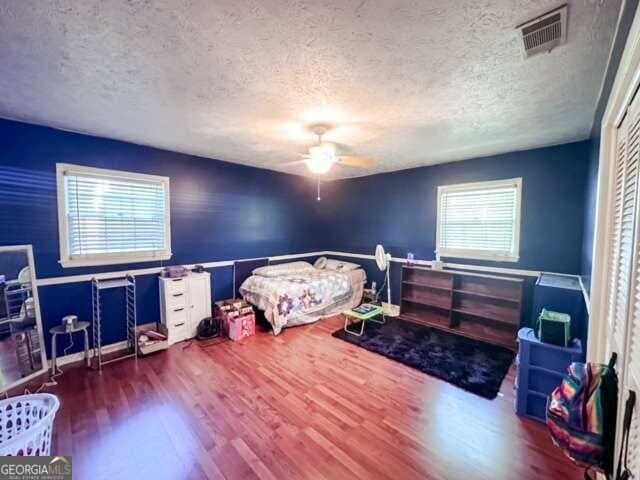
top-left (587, 7), bottom-right (640, 363)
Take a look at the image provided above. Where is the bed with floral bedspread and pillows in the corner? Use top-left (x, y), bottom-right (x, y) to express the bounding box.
top-left (239, 262), bottom-right (367, 335)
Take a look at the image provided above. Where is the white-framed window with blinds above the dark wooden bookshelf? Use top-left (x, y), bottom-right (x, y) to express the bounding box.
top-left (436, 178), bottom-right (522, 262)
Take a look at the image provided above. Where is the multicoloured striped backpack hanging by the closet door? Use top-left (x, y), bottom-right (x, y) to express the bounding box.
top-left (547, 353), bottom-right (618, 478)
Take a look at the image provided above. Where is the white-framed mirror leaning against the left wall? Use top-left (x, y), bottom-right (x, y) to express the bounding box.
top-left (0, 245), bottom-right (47, 392)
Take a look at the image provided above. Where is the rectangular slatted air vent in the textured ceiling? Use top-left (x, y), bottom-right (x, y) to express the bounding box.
top-left (517, 4), bottom-right (567, 58)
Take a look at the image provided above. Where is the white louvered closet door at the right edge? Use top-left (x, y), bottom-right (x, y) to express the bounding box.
top-left (609, 91), bottom-right (640, 478)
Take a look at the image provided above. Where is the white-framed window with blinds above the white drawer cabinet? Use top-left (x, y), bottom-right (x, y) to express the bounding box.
top-left (56, 163), bottom-right (171, 267)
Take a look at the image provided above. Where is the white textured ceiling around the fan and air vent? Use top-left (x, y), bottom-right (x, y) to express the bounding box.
top-left (0, 0), bottom-right (620, 177)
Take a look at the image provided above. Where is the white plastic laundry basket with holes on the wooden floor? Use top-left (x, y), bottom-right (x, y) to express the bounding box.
top-left (0, 393), bottom-right (60, 456)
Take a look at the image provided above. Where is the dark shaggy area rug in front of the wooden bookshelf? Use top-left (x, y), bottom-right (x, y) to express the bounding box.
top-left (332, 317), bottom-right (515, 399)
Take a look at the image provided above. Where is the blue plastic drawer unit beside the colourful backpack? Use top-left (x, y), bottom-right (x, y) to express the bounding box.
top-left (516, 328), bottom-right (583, 422)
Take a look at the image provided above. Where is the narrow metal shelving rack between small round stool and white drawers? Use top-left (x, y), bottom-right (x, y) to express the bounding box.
top-left (91, 275), bottom-right (138, 370)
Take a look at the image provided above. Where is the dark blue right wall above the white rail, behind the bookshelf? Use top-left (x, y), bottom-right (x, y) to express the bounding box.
top-left (320, 142), bottom-right (589, 274)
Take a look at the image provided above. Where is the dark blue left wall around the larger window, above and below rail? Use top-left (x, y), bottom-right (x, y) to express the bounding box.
top-left (0, 120), bottom-right (324, 348)
